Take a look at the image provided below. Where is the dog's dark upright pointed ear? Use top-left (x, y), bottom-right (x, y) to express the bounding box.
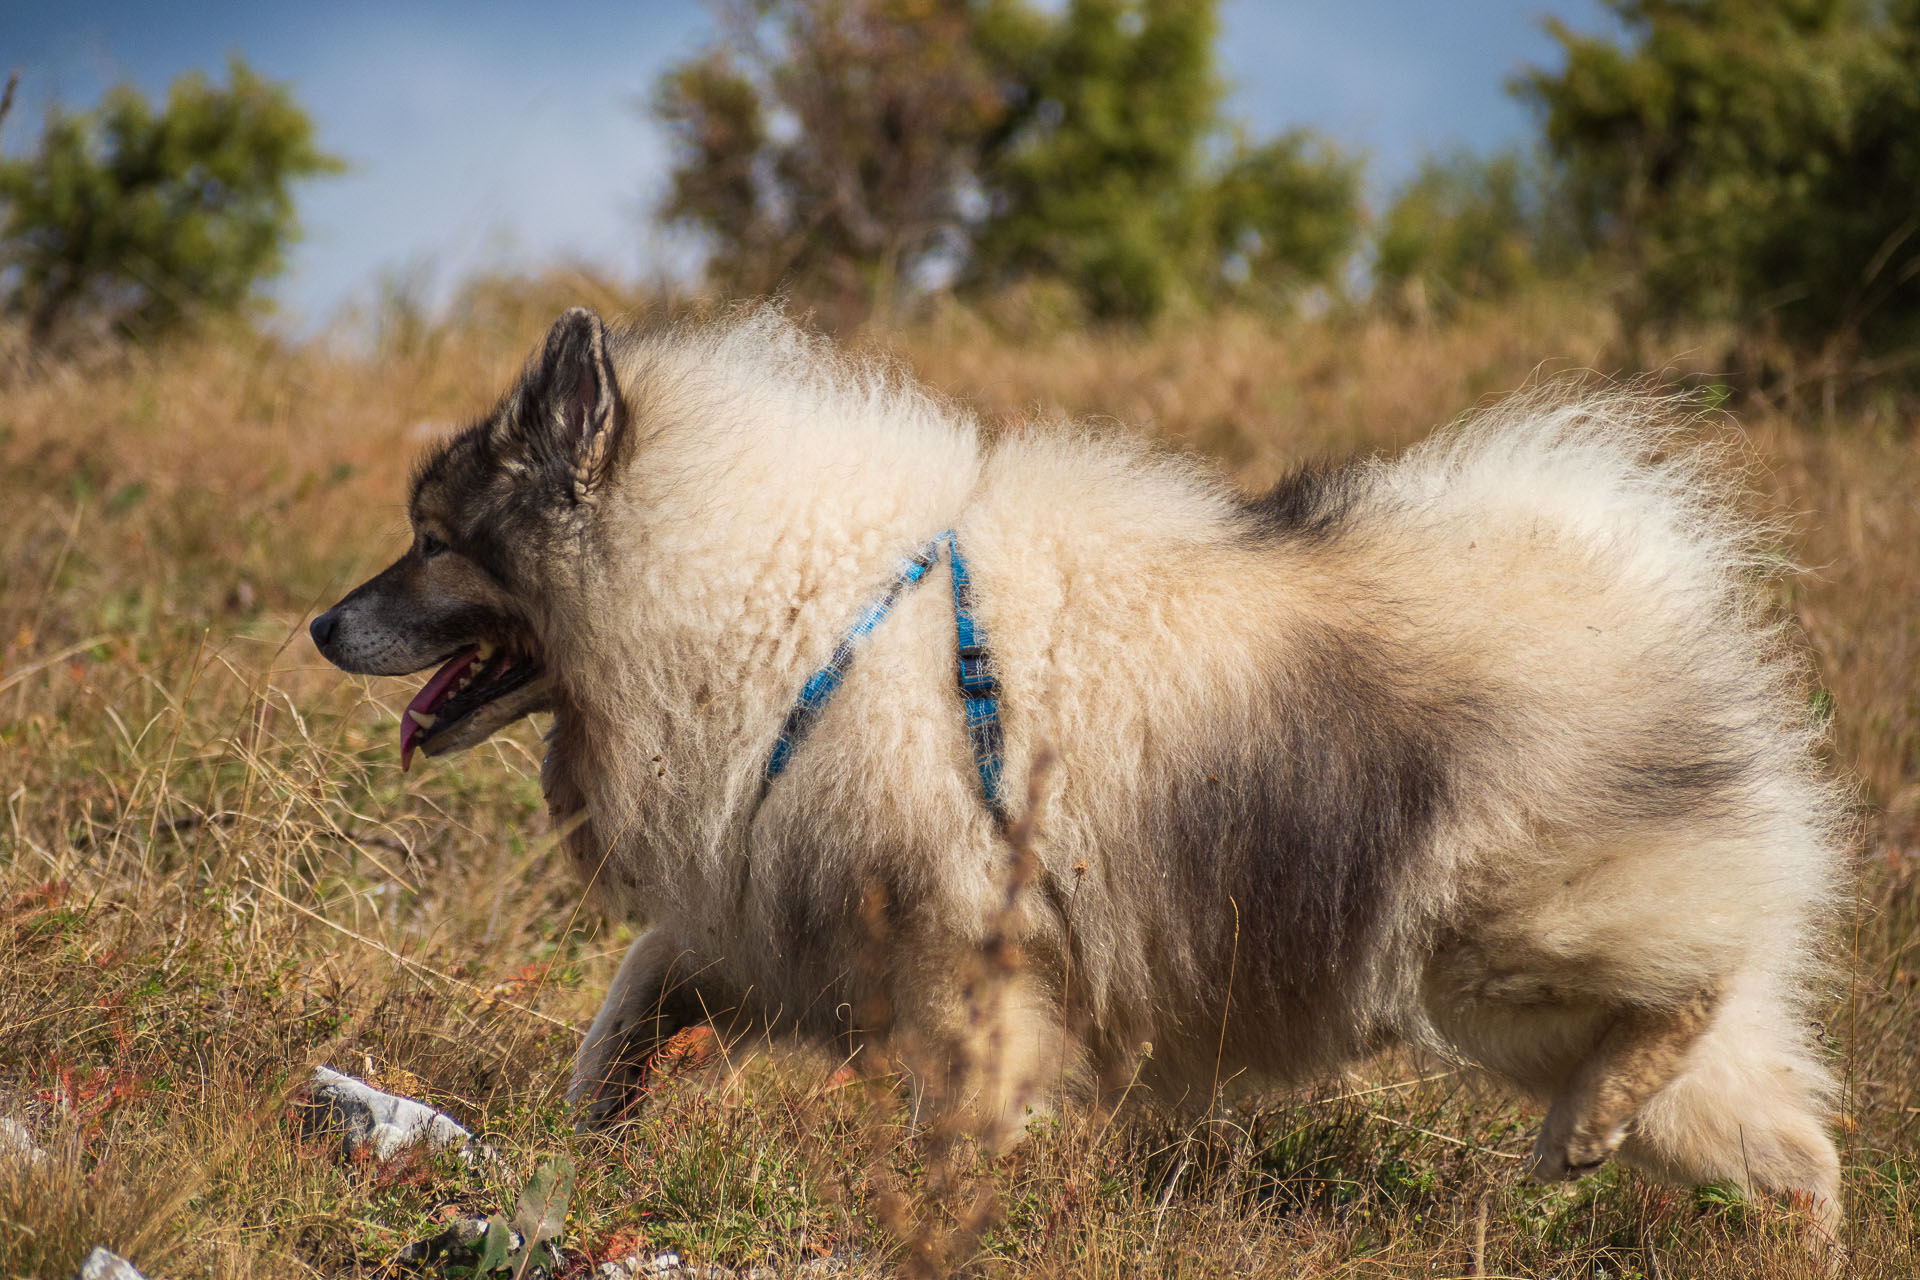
top-left (520, 307), bottom-right (626, 503)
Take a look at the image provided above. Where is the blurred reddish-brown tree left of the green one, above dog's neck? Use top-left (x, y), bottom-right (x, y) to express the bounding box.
top-left (653, 0), bottom-right (1000, 319)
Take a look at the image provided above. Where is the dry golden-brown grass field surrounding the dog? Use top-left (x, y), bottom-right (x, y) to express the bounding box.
top-left (0, 278), bottom-right (1920, 1280)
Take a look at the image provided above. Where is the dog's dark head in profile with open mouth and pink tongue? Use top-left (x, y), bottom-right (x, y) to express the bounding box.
top-left (311, 307), bottom-right (628, 766)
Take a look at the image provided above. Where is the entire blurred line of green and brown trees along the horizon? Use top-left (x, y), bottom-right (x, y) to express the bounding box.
top-left (0, 0), bottom-right (1920, 395)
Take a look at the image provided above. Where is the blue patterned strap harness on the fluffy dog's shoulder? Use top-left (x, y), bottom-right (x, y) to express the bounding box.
top-left (760, 530), bottom-right (1006, 821)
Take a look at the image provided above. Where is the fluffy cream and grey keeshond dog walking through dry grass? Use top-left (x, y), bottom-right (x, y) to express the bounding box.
top-left (313, 309), bottom-right (1849, 1226)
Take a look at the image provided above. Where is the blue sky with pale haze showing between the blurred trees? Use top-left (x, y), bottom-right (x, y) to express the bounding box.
top-left (0, 0), bottom-right (1609, 330)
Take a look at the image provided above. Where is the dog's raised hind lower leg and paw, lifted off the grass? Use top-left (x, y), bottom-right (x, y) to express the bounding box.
top-left (1528, 992), bottom-right (1718, 1182)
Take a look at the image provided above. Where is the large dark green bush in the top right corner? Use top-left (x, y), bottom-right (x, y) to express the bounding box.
top-left (1517, 0), bottom-right (1920, 368)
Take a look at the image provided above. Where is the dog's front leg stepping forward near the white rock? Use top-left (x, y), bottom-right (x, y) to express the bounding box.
top-left (566, 929), bottom-right (741, 1130)
